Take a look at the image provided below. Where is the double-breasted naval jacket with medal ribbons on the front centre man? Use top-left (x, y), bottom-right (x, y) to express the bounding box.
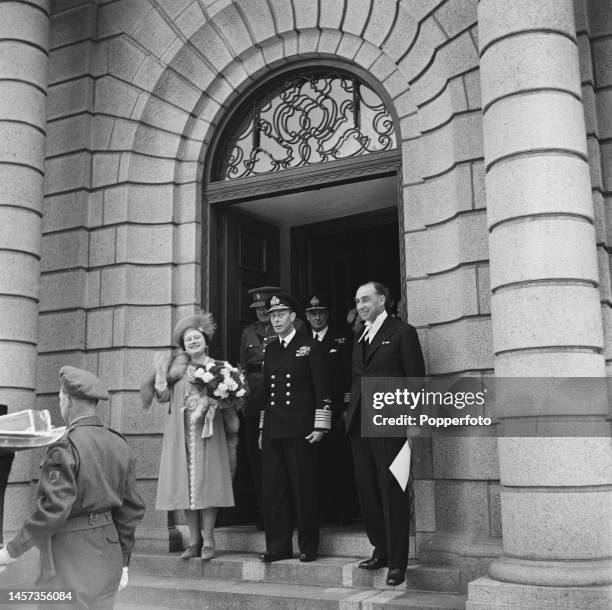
top-left (263, 333), bottom-right (331, 438)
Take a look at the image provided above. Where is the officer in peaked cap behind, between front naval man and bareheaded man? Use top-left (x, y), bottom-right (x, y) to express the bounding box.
top-left (304, 292), bottom-right (358, 525)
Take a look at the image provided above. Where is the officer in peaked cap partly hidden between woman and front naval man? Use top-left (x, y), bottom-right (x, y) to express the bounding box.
top-left (240, 286), bottom-right (281, 530)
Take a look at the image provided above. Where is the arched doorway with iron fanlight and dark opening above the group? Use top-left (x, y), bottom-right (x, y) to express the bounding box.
top-left (204, 63), bottom-right (403, 522)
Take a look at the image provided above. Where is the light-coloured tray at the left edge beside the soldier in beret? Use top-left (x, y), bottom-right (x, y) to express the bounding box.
top-left (0, 409), bottom-right (66, 451)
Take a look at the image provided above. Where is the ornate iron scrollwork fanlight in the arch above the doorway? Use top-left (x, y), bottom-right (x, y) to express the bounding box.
top-left (214, 73), bottom-right (396, 180)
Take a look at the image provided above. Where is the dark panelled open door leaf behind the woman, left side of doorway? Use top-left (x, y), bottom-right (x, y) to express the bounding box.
top-left (210, 205), bottom-right (280, 363)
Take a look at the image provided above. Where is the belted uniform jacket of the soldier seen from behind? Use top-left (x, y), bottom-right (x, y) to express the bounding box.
top-left (7, 415), bottom-right (145, 568)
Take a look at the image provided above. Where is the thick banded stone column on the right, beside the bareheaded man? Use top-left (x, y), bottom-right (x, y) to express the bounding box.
top-left (467, 0), bottom-right (612, 610)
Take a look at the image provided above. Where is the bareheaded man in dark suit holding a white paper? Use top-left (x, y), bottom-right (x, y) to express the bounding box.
top-left (346, 282), bottom-right (425, 586)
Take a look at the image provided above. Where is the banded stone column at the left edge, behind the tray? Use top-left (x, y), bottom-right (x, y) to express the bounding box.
top-left (0, 0), bottom-right (49, 411)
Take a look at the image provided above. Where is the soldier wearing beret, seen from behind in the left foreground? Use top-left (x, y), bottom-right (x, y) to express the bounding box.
top-left (0, 366), bottom-right (145, 608)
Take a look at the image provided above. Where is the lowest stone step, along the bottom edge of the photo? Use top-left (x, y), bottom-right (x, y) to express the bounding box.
top-left (117, 574), bottom-right (465, 610)
